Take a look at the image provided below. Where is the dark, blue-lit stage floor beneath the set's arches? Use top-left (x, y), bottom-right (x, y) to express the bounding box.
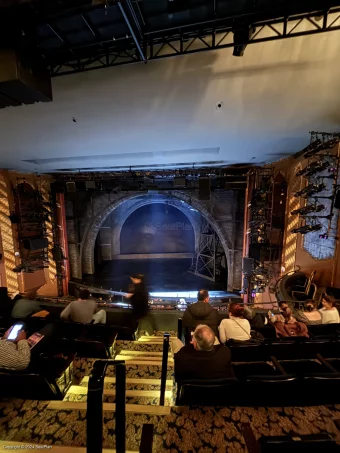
top-left (79, 258), bottom-right (231, 293)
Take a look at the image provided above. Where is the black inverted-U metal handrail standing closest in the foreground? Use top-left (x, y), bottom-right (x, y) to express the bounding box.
top-left (86, 360), bottom-right (126, 453)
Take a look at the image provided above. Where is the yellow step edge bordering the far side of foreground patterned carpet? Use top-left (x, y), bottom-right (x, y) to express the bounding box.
top-left (47, 401), bottom-right (171, 415)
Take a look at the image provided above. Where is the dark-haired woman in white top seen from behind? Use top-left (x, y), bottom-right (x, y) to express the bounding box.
top-left (218, 302), bottom-right (251, 343)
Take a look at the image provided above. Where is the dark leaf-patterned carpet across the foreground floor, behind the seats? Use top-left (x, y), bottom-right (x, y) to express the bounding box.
top-left (0, 400), bottom-right (340, 453)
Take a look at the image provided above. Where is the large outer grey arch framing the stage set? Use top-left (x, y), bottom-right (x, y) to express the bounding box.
top-left (80, 191), bottom-right (233, 288)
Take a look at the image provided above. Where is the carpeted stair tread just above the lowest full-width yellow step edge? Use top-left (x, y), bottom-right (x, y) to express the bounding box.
top-left (64, 385), bottom-right (172, 406)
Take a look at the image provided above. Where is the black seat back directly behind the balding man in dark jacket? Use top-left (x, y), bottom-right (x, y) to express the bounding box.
top-left (176, 378), bottom-right (240, 406)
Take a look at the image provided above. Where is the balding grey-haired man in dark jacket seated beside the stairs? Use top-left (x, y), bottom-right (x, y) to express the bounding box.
top-left (171, 325), bottom-right (234, 383)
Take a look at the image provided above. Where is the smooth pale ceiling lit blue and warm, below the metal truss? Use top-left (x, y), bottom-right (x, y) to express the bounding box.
top-left (0, 3), bottom-right (340, 173)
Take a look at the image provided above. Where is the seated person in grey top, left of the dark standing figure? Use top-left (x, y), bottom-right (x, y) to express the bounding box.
top-left (60, 289), bottom-right (106, 324)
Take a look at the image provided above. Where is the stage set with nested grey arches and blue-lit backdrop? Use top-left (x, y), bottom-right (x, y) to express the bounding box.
top-left (66, 190), bottom-right (244, 291)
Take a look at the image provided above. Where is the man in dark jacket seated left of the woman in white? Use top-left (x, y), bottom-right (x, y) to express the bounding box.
top-left (183, 289), bottom-right (220, 335)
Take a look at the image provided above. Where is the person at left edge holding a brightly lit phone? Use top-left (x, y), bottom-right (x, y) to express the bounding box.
top-left (0, 324), bottom-right (31, 370)
